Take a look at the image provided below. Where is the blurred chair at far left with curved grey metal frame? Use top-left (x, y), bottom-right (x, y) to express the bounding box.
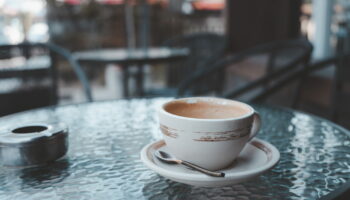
top-left (0, 43), bottom-right (92, 116)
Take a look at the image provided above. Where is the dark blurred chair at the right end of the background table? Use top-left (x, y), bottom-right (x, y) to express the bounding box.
top-left (147, 33), bottom-right (226, 96)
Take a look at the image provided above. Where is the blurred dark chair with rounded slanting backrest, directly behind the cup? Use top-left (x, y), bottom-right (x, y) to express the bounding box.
top-left (177, 39), bottom-right (312, 108)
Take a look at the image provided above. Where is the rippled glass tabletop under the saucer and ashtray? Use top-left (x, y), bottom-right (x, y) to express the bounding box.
top-left (0, 98), bottom-right (350, 200)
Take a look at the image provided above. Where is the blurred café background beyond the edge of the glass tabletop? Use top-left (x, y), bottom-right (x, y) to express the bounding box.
top-left (0, 0), bottom-right (350, 128)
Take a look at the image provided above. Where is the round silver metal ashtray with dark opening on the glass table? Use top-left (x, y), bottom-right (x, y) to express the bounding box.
top-left (0, 123), bottom-right (68, 166)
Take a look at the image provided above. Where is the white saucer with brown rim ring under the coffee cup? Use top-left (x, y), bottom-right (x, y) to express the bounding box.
top-left (141, 139), bottom-right (280, 187)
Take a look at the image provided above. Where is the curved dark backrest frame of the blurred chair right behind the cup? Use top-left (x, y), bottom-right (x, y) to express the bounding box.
top-left (178, 39), bottom-right (312, 104)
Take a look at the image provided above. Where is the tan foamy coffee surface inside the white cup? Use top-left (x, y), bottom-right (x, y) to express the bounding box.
top-left (164, 100), bottom-right (250, 119)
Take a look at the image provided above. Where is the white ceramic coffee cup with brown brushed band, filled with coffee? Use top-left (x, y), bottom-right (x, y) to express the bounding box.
top-left (158, 97), bottom-right (261, 170)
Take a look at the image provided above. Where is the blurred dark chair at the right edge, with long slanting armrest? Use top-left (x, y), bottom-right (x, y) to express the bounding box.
top-left (179, 45), bottom-right (350, 124)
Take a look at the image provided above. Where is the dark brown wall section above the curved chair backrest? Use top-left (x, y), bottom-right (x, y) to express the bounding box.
top-left (226, 0), bottom-right (301, 51)
